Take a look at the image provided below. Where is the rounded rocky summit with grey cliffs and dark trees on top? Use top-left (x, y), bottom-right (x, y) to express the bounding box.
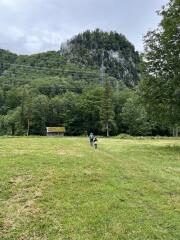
top-left (60, 29), bottom-right (140, 87)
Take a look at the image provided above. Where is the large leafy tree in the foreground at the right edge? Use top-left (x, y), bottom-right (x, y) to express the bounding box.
top-left (141, 0), bottom-right (180, 134)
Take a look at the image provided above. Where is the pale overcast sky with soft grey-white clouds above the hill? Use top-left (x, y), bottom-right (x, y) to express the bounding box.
top-left (0, 0), bottom-right (168, 54)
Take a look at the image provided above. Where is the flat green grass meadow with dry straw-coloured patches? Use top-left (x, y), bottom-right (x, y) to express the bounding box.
top-left (0, 137), bottom-right (180, 240)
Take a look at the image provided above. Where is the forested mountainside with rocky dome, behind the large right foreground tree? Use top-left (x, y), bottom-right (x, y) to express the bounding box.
top-left (0, 30), bottom-right (169, 135)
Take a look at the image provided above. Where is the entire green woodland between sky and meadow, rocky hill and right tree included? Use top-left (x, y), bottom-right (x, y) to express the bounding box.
top-left (0, 0), bottom-right (180, 136)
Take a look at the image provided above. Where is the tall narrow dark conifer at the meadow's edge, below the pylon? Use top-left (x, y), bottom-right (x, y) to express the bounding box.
top-left (100, 79), bottom-right (115, 137)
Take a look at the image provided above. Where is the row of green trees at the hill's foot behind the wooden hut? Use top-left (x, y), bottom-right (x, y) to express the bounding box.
top-left (0, 78), bottom-right (169, 135)
